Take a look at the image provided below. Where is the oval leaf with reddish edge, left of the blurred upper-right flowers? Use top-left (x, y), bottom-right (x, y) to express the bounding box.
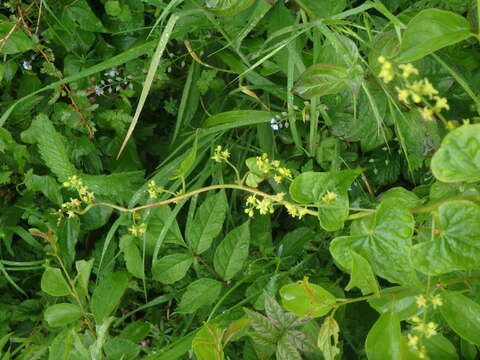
top-left (292, 64), bottom-right (362, 99)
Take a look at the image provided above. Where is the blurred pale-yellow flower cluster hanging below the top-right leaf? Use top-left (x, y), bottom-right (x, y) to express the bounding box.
top-left (378, 56), bottom-right (450, 120)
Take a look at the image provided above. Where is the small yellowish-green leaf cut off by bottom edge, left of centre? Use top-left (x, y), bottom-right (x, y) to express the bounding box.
top-left (192, 323), bottom-right (225, 360)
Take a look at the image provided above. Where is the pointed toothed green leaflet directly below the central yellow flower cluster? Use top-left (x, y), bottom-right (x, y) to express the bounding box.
top-left (213, 221), bottom-right (250, 281)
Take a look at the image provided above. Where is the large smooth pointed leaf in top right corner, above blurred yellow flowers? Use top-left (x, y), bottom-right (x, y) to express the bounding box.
top-left (395, 9), bottom-right (473, 63)
